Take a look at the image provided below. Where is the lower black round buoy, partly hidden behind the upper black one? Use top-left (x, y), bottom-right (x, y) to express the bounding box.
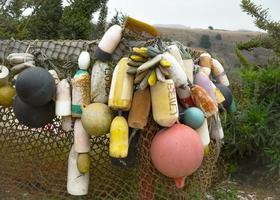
top-left (13, 96), bottom-right (55, 128)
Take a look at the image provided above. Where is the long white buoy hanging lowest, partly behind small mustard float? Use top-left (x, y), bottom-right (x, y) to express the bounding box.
top-left (67, 146), bottom-right (89, 196)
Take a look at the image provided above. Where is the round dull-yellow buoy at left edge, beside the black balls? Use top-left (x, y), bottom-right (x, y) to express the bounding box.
top-left (0, 85), bottom-right (16, 107)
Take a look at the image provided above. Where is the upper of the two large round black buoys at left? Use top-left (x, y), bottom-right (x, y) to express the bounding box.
top-left (16, 67), bottom-right (56, 106)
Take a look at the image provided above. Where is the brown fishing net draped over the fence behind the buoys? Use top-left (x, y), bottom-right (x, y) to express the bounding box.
top-left (0, 40), bottom-right (221, 200)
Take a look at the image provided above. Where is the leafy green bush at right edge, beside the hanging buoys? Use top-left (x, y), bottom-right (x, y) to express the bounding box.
top-left (224, 64), bottom-right (280, 175)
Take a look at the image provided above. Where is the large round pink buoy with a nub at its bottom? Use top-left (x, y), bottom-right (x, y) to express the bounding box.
top-left (151, 124), bottom-right (204, 188)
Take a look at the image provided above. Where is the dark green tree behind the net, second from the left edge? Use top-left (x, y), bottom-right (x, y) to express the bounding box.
top-left (27, 0), bottom-right (63, 39)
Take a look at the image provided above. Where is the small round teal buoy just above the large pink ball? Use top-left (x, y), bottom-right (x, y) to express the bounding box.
top-left (180, 107), bottom-right (205, 129)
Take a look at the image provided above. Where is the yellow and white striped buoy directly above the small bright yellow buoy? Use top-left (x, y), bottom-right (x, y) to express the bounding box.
top-left (108, 58), bottom-right (134, 111)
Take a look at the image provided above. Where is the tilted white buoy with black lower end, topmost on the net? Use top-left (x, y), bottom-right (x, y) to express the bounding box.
top-left (94, 25), bottom-right (122, 62)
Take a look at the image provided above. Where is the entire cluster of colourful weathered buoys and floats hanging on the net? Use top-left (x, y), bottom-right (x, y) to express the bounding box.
top-left (0, 17), bottom-right (235, 196)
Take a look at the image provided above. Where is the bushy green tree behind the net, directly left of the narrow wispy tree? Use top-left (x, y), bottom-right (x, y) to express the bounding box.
top-left (60, 0), bottom-right (107, 39)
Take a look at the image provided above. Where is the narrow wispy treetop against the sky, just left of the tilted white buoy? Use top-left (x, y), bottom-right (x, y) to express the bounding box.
top-left (96, 0), bottom-right (108, 38)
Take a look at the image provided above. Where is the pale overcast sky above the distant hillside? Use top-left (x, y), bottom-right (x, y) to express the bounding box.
top-left (103, 0), bottom-right (280, 30)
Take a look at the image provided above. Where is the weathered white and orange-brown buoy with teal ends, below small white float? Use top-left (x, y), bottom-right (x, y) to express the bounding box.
top-left (71, 69), bottom-right (90, 117)
